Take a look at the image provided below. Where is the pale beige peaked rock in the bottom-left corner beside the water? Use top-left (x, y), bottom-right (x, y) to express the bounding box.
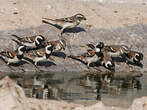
top-left (0, 77), bottom-right (31, 110)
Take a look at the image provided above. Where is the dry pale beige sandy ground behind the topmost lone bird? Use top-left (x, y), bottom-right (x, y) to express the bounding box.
top-left (0, 0), bottom-right (147, 30)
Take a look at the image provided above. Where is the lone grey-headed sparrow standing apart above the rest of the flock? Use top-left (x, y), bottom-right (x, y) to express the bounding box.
top-left (42, 13), bottom-right (86, 35)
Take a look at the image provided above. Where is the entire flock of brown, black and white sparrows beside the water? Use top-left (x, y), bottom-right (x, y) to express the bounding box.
top-left (0, 13), bottom-right (143, 71)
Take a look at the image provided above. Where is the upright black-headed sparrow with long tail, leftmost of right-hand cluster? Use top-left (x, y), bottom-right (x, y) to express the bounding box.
top-left (68, 42), bottom-right (104, 68)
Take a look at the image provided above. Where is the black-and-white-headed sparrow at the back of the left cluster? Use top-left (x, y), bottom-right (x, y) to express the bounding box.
top-left (12, 34), bottom-right (46, 49)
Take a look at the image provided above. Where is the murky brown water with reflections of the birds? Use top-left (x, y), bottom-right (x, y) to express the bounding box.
top-left (1, 72), bottom-right (147, 108)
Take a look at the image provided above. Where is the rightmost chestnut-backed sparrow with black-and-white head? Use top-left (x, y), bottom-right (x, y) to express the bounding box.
top-left (125, 50), bottom-right (143, 64)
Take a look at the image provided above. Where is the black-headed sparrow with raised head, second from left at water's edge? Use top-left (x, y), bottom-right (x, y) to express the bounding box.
top-left (24, 45), bottom-right (53, 71)
